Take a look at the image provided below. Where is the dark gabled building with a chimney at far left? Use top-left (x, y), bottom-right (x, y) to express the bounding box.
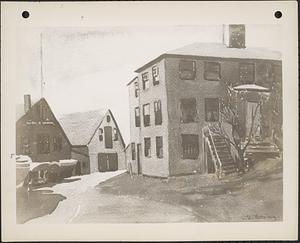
top-left (16, 95), bottom-right (71, 162)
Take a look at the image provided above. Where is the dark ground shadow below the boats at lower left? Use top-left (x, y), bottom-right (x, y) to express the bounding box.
top-left (16, 187), bottom-right (66, 224)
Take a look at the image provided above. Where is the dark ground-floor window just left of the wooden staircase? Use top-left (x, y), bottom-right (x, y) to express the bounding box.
top-left (181, 134), bottom-right (199, 159)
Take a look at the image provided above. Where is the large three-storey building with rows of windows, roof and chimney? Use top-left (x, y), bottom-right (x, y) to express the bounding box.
top-left (128, 25), bottom-right (282, 177)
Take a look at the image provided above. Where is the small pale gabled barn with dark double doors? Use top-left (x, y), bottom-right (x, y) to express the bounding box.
top-left (59, 110), bottom-right (125, 174)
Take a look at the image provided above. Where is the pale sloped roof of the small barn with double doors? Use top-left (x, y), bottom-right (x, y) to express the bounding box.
top-left (58, 109), bottom-right (108, 145)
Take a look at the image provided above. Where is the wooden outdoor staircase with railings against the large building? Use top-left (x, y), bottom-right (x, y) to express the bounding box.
top-left (203, 127), bottom-right (237, 177)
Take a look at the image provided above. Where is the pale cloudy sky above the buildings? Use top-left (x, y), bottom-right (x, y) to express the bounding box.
top-left (16, 25), bottom-right (281, 143)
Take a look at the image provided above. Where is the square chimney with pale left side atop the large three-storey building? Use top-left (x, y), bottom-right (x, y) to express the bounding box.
top-left (223, 24), bottom-right (246, 48)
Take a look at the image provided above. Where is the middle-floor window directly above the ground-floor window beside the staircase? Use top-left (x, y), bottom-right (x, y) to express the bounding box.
top-left (180, 98), bottom-right (197, 123)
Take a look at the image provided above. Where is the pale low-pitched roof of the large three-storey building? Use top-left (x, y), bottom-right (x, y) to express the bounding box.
top-left (135, 42), bottom-right (281, 73)
